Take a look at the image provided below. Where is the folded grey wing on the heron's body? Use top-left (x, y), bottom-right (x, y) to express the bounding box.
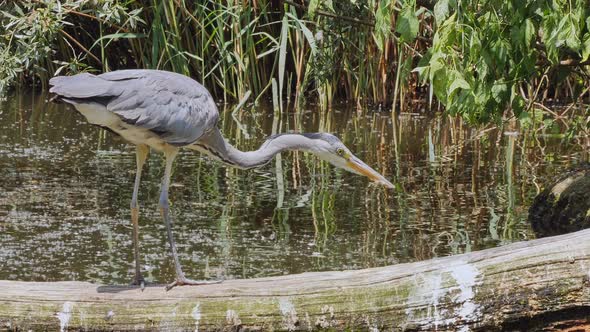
top-left (98, 70), bottom-right (219, 146)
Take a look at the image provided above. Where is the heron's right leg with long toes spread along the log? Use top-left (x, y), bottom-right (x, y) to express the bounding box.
top-left (160, 149), bottom-right (222, 290)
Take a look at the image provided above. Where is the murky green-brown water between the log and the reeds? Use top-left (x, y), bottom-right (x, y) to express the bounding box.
top-left (0, 95), bottom-right (588, 283)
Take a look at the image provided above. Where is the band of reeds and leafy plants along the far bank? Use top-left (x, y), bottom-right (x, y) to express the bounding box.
top-left (0, 0), bottom-right (590, 126)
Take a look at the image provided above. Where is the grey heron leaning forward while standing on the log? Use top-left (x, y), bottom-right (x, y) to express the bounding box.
top-left (49, 70), bottom-right (393, 289)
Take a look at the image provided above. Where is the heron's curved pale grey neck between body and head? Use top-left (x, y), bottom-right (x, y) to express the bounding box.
top-left (194, 128), bottom-right (315, 169)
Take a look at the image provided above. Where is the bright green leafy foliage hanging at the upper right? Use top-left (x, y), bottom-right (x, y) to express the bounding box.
top-left (415, 0), bottom-right (590, 122)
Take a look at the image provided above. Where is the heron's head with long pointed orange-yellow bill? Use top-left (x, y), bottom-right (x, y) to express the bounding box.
top-left (301, 133), bottom-right (394, 188)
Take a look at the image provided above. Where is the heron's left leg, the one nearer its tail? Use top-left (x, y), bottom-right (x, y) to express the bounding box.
top-left (131, 144), bottom-right (150, 289)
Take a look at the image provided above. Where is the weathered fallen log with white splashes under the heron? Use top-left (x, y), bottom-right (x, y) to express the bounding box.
top-left (0, 230), bottom-right (590, 331)
